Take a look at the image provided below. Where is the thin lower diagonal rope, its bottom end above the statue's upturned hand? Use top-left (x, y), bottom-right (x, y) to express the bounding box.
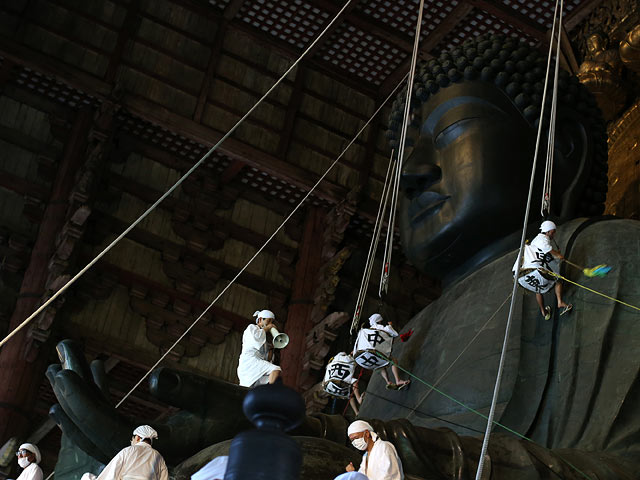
top-left (116, 78), bottom-right (404, 408)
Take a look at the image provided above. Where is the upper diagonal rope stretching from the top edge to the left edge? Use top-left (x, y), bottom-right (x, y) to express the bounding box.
top-left (0, 0), bottom-right (353, 348)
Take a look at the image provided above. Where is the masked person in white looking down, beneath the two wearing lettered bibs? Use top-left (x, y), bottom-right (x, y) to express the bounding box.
top-left (346, 420), bottom-right (404, 480)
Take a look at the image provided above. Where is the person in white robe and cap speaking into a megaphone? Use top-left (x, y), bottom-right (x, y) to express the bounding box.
top-left (238, 310), bottom-right (281, 387)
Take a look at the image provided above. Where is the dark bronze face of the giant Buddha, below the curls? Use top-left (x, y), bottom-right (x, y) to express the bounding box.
top-left (400, 82), bottom-right (535, 277)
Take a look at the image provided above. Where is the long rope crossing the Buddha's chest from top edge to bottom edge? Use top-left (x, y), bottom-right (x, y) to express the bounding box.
top-left (476, 0), bottom-right (563, 480)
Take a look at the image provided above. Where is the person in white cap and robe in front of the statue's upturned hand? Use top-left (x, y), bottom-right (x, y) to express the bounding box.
top-left (82, 425), bottom-right (169, 480)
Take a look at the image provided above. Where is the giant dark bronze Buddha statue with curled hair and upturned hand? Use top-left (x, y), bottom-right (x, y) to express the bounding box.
top-left (49, 36), bottom-right (640, 480)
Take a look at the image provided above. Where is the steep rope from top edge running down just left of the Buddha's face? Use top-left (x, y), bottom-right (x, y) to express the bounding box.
top-left (378, 0), bottom-right (424, 298)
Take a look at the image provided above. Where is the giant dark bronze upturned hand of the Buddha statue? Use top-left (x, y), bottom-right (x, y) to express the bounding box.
top-left (47, 340), bottom-right (249, 464)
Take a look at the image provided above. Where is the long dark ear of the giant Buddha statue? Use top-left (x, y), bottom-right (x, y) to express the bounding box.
top-left (541, 107), bottom-right (593, 221)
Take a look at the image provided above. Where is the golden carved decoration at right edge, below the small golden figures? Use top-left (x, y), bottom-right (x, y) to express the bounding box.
top-left (605, 101), bottom-right (640, 220)
